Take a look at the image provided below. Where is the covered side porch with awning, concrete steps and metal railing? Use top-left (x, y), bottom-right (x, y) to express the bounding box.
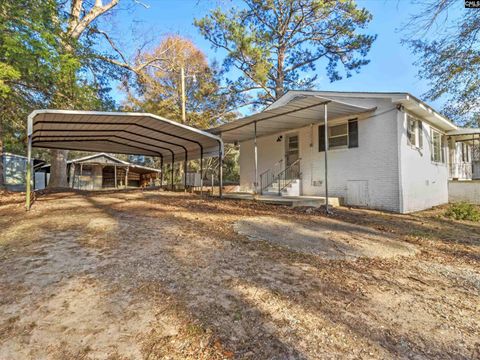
top-left (213, 94), bottom-right (376, 211)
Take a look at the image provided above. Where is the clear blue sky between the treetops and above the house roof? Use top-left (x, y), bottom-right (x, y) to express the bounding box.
top-left (105, 0), bottom-right (446, 109)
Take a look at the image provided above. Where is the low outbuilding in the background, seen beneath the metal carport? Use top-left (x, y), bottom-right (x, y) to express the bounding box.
top-left (35, 153), bottom-right (161, 190)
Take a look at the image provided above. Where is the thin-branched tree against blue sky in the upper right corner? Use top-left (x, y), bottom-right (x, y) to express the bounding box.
top-left (404, 0), bottom-right (480, 126)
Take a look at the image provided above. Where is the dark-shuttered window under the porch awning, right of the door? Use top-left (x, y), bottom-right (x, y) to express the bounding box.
top-left (318, 119), bottom-right (358, 151)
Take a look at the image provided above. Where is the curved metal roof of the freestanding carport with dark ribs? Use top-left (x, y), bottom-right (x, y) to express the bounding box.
top-left (28, 110), bottom-right (223, 161)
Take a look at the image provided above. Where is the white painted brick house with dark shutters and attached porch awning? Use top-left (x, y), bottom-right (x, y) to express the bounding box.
top-left (211, 91), bottom-right (480, 213)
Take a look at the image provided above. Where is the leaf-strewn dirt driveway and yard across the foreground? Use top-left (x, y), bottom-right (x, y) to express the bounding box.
top-left (0, 191), bottom-right (480, 360)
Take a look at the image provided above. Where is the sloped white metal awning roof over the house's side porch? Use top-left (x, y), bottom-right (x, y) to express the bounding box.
top-left (209, 95), bottom-right (375, 142)
